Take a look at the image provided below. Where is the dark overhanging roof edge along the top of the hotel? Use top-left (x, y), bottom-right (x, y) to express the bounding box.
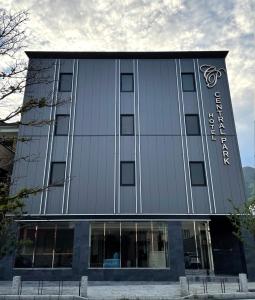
top-left (25, 50), bottom-right (228, 59)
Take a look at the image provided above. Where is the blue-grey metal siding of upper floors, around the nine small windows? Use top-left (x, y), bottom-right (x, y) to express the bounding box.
top-left (10, 54), bottom-right (245, 214)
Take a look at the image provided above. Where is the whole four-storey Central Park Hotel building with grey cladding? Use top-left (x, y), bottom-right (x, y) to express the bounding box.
top-left (1, 51), bottom-right (255, 280)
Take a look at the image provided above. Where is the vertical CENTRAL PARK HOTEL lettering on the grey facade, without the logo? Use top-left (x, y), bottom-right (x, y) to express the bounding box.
top-left (208, 92), bottom-right (230, 165)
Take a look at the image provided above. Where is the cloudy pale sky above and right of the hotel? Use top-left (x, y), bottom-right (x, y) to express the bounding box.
top-left (0, 0), bottom-right (255, 166)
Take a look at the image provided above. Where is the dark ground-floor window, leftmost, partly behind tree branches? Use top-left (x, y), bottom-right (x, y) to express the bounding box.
top-left (15, 223), bottom-right (74, 268)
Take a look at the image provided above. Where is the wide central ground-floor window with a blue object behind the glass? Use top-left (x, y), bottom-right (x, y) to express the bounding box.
top-left (90, 222), bottom-right (169, 268)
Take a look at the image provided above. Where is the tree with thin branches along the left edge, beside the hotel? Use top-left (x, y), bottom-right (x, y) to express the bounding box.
top-left (0, 9), bottom-right (58, 258)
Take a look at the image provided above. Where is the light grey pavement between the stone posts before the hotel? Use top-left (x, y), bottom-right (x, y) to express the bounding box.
top-left (0, 281), bottom-right (255, 300)
